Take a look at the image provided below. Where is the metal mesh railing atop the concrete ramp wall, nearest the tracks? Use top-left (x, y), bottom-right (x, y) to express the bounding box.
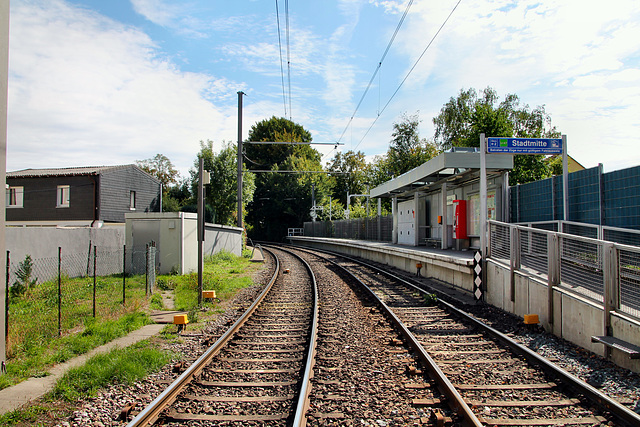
top-left (488, 221), bottom-right (640, 318)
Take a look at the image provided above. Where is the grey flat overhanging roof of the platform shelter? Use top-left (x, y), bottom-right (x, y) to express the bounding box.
top-left (370, 151), bottom-right (513, 198)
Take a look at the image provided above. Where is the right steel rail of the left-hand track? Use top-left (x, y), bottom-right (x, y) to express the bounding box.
top-left (264, 248), bottom-right (318, 427)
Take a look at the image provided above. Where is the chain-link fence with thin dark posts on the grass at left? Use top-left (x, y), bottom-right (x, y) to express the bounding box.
top-left (5, 245), bottom-right (156, 353)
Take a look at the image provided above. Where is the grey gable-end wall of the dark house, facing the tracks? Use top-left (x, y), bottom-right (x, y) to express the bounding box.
top-left (99, 165), bottom-right (162, 222)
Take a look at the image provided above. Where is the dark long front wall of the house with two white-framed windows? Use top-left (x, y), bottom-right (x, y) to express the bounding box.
top-left (6, 176), bottom-right (96, 221)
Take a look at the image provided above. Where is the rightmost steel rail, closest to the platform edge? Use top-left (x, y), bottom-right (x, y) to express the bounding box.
top-left (298, 249), bottom-right (640, 426)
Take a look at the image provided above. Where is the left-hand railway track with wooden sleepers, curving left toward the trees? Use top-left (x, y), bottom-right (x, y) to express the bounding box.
top-left (128, 249), bottom-right (318, 427)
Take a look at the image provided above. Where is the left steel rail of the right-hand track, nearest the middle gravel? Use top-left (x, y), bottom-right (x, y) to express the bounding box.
top-left (290, 248), bottom-right (484, 427)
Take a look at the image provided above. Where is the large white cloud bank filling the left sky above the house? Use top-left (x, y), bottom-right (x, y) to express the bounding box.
top-left (7, 0), bottom-right (240, 177)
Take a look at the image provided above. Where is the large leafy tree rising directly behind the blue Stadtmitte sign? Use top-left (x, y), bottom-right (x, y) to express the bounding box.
top-left (433, 87), bottom-right (560, 185)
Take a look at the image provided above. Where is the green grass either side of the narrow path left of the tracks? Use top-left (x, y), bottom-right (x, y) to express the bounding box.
top-left (0, 249), bottom-right (260, 426)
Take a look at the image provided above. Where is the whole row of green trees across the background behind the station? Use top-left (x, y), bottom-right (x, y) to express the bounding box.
top-left (137, 87), bottom-right (562, 241)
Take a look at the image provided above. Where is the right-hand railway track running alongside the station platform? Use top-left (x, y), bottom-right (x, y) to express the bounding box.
top-left (292, 246), bottom-right (640, 426)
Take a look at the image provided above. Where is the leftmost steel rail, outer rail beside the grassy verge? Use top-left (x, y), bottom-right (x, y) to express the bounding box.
top-left (127, 247), bottom-right (280, 427)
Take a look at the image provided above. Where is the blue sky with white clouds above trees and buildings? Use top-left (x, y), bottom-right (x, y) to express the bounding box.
top-left (7, 0), bottom-right (640, 177)
